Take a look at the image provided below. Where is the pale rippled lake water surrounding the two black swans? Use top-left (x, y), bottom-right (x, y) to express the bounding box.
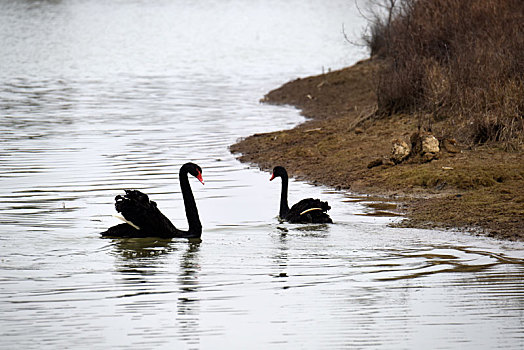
top-left (0, 0), bottom-right (524, 349)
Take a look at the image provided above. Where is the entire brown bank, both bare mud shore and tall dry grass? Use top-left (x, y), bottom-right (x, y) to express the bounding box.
top-left (231, 0), bottom-right (524, 240)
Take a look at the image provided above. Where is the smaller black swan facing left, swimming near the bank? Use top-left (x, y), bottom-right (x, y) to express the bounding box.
top-left (269, 166), bottom-right (333, 224)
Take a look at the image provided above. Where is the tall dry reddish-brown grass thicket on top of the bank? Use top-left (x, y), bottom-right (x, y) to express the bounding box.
top-left (365, 0), bottom-right (524, 148)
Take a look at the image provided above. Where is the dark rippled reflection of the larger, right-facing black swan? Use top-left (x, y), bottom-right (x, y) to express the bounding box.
top-left (112, 238), bottom-right (202, 346)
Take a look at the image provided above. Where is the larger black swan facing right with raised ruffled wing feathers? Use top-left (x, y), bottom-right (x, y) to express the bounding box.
top-left (101, 163), bottom-right (204, 238)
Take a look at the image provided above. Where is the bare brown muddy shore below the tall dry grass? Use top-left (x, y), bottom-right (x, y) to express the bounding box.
top-left (231, 60), bottom-right (524, 240)
